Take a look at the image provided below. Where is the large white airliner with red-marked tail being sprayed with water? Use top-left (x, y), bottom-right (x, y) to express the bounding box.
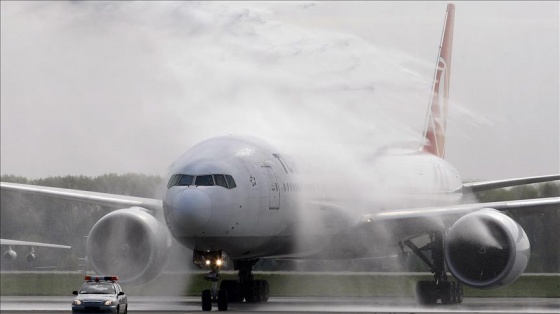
top-left (1, 4), bottom-right (560, 311)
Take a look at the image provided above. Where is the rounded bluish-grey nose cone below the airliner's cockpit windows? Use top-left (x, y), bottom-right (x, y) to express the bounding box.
top-left (172, 189), bottom-right (212, 230)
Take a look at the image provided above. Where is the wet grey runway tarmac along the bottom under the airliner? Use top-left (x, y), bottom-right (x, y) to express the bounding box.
top-left (0, 296), bottom-right (560, 314)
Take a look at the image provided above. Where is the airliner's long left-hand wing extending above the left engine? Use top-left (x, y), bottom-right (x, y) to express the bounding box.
top-left (0, 182), bottom-right (163, 211)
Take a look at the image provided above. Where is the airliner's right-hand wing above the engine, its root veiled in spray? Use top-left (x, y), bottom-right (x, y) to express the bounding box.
top-left (300, 197), bottom-right (560, 259)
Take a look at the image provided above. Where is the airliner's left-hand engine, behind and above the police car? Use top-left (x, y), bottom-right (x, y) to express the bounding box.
top-left (86, 207), bottom-right (171, 284)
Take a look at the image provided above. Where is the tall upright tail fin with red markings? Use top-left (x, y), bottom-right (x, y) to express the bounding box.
top-left (422, 3), bottom-right (455, 158)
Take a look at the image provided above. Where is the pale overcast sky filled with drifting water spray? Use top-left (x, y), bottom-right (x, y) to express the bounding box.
top-left (0, 1), bottom-right (560, 180)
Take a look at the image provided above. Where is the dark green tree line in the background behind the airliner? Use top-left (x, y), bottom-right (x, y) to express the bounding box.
top-left (0, 173), bottom-right (560, 273)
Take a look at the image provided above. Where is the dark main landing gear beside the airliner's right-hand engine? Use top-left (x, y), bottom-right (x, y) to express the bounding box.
top-left (399, 231), bottom-right (463, 305)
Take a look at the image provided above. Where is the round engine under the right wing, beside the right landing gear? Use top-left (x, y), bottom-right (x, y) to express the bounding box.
top-left (445, 208), bottom-right (530, 289)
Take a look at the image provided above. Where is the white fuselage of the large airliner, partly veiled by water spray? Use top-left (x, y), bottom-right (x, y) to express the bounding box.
top-left (163, 136), bottom-right (461, 259)
